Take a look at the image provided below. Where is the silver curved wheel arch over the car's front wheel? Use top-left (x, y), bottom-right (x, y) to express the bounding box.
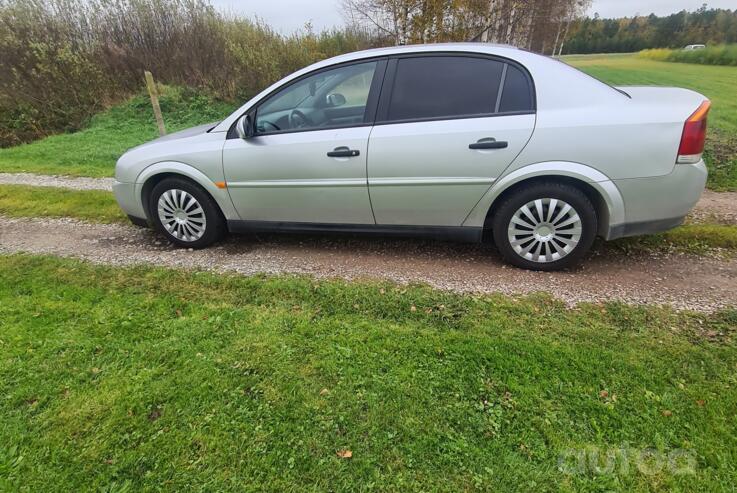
top-left (131, 162), bottom-right (238, 220)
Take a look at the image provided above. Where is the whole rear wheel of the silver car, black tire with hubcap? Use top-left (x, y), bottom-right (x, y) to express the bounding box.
top-left (492, 182), bottom-right (598, 271)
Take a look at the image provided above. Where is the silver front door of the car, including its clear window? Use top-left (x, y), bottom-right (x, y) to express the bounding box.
top-left (223, 61), bottom-right (383, 224)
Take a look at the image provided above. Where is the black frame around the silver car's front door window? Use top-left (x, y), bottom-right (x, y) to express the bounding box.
top-left (226, 56), bottom-right (387, 139)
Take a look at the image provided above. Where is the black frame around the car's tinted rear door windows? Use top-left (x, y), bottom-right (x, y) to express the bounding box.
top-left (374, 51), bottom-right (537, 125)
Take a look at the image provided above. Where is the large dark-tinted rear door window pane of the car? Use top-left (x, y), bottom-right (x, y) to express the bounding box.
top-left (387, 56), bottom-right (505, 121)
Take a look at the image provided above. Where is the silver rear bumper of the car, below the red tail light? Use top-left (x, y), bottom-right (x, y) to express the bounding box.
top-left (607, 161), bottom-right (708, 240)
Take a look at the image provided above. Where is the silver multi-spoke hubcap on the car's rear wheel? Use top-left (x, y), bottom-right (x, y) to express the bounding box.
top-left (507, 198), bottom-right (582, 263)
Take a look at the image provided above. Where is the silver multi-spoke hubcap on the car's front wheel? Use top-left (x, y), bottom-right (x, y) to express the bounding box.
top-left (158, 190), bottom-right (207, 242)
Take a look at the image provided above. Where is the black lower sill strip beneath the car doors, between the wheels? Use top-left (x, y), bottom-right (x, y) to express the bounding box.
top-left (228, 221), bottom-right (484, 243)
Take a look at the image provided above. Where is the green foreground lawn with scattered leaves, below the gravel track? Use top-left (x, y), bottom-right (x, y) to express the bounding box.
top-left (0, 252), bottom-right (737, 491)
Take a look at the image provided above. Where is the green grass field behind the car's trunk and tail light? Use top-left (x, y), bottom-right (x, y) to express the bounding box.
top-left (564, 54), bottom-right (737, 191)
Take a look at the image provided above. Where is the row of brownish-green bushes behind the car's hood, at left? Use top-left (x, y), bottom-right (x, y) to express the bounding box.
top-left (0, 0), bottom-right (370, 146)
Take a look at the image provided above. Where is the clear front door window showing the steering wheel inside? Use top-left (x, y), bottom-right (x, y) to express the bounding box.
top-left (256, 62), bottom-right (377, 135)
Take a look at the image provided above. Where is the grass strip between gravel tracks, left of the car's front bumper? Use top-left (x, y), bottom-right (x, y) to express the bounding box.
top-left (0, 185), bottom-right (128, 223)
